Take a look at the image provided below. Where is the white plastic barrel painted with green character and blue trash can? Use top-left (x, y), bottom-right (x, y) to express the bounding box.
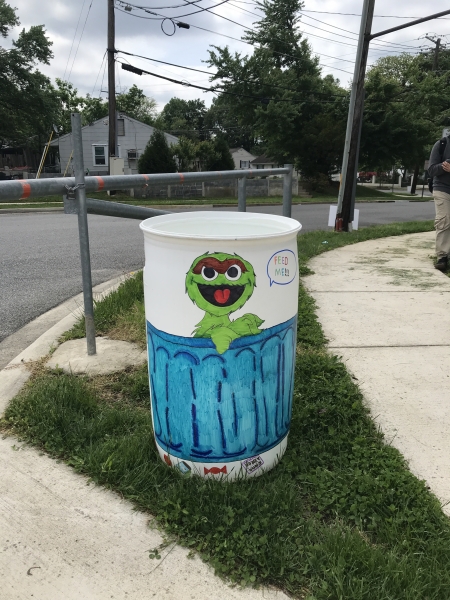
top-left (140, 212), bottom-right (301, 480)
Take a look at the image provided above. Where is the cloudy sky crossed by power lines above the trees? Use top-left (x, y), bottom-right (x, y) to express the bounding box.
top-left (5, 0), bottom-right (450, 108)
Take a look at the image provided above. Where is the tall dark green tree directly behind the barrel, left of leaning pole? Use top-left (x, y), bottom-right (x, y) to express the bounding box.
top-left (208, 0), bottom-right (348, 176)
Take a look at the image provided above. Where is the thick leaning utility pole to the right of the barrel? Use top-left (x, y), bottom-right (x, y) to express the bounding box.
top-left (335, 0), bottom-right (375, 231)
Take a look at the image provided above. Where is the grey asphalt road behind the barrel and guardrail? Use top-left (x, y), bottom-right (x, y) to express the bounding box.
top-left (0, 201), bottom-right (434, 368)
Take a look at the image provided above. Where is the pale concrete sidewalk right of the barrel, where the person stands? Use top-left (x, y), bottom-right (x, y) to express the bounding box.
top-left (304, 232), bottom-right (450, 514)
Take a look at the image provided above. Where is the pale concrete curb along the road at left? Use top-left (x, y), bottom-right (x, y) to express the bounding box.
top-left (0, 275), bottom-right (133, 417)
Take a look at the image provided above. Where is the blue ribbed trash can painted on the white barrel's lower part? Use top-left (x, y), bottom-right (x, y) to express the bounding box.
top-left (147, 317), bottom-right (297, 462)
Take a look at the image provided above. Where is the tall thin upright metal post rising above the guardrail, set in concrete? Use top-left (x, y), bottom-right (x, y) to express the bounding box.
top-left (71, 113), bottom-right (97, 356)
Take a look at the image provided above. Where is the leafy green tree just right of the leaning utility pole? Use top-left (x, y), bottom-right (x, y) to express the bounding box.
top-left (360, 53), bottom-right (450, 172)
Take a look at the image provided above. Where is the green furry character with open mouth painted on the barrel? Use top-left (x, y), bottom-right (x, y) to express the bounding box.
top-left (186, 252), bottom-right (264, 354)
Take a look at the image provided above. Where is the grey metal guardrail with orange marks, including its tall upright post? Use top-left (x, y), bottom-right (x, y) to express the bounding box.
top-left (0, 113), bottom-right (293, 355)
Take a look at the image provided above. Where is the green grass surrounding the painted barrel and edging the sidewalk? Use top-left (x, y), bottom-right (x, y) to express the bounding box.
top-left (2, 223), bottom-right (450, 600)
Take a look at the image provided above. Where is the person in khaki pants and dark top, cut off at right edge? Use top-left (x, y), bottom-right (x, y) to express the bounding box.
top-left (428, 137), bottom-right (450, 272)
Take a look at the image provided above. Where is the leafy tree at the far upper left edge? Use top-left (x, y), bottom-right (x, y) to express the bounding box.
top-left (0, 0), bottom-right (56, 149)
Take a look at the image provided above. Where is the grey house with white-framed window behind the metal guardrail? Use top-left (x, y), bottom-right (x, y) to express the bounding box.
top-left (50, 113), bottom-right (178, 175)
